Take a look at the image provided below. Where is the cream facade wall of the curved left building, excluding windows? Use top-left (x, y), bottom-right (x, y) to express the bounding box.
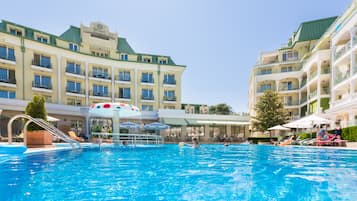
top-left (0, 21), bottom-right (185, 113)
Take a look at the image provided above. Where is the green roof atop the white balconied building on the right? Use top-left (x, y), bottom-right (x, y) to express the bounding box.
top-left (292, 17), bottom-right (337, 45)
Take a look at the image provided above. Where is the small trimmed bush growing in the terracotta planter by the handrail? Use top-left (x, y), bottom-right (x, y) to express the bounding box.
top-left (25, 95), bottom-right (47, 131)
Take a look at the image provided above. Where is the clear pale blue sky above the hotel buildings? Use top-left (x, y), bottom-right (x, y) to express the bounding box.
top-left (0, 0), bottom-right (351, 112)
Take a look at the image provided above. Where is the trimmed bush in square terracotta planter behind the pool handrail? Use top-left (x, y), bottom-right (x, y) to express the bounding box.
top-left (25, 95), bottom-right (52, 147)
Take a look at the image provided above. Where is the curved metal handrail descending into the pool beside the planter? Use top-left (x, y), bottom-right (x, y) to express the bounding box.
top-left (7, 114), bottom-right (81, 148)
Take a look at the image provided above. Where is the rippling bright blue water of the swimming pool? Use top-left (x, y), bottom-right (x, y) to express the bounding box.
top-left (0, 145), bottom-right (357, 201)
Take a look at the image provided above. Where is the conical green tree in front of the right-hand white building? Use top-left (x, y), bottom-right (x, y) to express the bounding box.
top-left (252, 90), bottom-right (288, 131)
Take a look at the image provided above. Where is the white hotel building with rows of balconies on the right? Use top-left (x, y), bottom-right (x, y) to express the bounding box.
top-left (249, 1), bottom-right (357, 126)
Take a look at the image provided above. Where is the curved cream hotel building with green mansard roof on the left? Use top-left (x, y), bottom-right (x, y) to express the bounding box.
top-left (0, 20), bottom-right (186, 135)
